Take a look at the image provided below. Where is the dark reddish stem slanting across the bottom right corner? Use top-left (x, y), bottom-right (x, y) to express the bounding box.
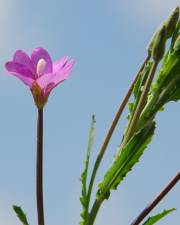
top-left (131, 172), bottom-right (180, 225)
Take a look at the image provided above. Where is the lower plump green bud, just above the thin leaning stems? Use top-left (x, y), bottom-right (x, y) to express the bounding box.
top-left (152, 26), bottom-right (166, 62)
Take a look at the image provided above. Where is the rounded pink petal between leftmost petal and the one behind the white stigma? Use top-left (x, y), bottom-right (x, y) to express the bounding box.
top-left (13, 50), bottom-right (35, 73)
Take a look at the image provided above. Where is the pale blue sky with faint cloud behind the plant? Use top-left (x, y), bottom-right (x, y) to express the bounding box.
top-left (0, 0), bottom-right (180, 225)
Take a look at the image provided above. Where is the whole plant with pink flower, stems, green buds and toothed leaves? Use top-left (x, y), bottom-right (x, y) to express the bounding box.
top-left (2, 4), bottom-right (180, 225)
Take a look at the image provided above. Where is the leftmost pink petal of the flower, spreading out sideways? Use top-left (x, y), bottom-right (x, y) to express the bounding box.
top-left (5, 62), bottom-right (34, 87)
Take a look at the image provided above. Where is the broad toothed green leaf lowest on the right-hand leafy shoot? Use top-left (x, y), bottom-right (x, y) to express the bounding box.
top-left (97, 121), bottom-right (155, 198)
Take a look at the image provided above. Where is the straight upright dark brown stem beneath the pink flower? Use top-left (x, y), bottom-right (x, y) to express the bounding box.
top-left (36, 109), bottom-right (44, 225)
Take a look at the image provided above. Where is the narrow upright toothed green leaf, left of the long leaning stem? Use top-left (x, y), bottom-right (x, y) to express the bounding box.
top-left (80, 115), bottom-right (96, 225)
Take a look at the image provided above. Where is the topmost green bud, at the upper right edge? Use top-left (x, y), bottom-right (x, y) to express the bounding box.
top-left (164, 6), bottom-right (179, 39)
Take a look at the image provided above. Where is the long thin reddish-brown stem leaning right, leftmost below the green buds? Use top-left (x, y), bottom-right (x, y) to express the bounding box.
top-left (87, 55), bottom-right (150, 221)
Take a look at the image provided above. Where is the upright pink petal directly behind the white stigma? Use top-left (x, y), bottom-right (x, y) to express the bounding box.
top-left (31, 48), bottom-right (52, 74)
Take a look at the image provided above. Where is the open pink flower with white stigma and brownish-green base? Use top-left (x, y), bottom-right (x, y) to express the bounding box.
top-left (5, 48), bottom-right (75, 108)
